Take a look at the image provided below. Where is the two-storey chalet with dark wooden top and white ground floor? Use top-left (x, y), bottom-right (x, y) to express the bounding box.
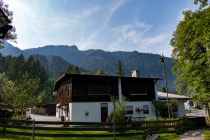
top-left (54, 74), bottom-right (158, 122)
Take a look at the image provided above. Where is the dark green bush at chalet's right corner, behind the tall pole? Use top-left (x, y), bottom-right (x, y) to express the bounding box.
top-left (156, 100), bottom-right (178, 118)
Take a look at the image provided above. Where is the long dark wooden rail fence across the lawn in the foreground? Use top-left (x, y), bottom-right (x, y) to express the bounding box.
top-left (0, 119), bottom-right (182, 139)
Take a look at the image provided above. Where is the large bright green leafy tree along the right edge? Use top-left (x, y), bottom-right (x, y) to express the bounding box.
top-left (171, 7), bottom-right (210, 105)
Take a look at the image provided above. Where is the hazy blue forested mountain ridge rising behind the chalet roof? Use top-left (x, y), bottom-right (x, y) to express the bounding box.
top-left (0, 41), bottom-right (175, 91)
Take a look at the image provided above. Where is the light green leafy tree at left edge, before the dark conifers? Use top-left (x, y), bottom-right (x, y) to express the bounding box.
top-left (0, 73), bottom-right (44, 118)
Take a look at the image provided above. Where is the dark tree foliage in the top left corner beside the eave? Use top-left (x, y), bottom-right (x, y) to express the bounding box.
top-left (0, 0), bottom-right (17, 40)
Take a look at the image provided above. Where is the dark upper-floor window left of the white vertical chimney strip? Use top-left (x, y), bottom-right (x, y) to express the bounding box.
top-left (88, 85), bottom-right (110, 95)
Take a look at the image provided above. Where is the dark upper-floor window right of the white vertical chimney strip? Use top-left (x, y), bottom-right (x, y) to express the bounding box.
top-left (128, 86), bottom-right (147, 95)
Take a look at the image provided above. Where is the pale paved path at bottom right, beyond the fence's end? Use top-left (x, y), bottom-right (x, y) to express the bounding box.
top-left (180, 129), bottom-right (204, 140)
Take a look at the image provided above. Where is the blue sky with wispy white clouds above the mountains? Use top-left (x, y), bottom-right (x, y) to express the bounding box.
top-left (4, 0), bottom-right (197, 57)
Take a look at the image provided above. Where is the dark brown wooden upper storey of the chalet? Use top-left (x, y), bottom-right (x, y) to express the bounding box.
top-left (54, 74), bottom-right (158, 105)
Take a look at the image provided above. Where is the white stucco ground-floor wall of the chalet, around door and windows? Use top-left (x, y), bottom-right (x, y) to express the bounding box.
top-left (69, 101), bottom-right (155, 122)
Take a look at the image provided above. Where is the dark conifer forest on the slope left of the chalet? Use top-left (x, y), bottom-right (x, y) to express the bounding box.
top-left (0, 55), bottom-right (55, 107)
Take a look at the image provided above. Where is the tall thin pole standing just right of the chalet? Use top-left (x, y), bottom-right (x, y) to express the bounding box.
top-left (160, 53), bottom-right (171, 119)
